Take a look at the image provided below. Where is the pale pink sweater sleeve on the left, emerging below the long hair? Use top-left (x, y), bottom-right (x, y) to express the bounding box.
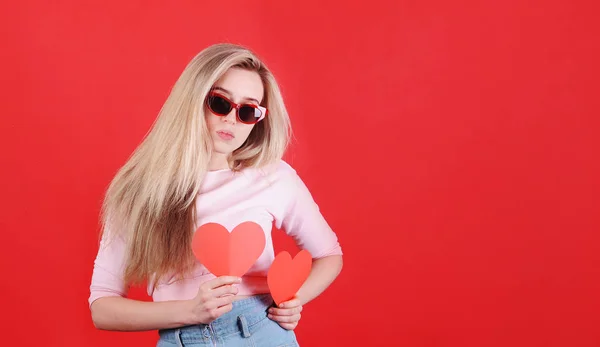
top-left (88, 228), bottom-right (127, 306)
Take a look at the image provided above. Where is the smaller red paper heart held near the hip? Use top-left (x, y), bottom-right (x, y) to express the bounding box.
top-left (267, 250), bottom-right (312, 305)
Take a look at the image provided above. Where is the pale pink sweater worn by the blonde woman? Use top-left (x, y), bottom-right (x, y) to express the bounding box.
top-left (89, 161), bottom-right (342, 305)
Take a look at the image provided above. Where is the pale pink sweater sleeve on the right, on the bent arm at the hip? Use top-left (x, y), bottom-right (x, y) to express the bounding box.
top-left (277, 164), bottom-right (342, 259)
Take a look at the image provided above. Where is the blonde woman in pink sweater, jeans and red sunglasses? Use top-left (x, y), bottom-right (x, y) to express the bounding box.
top-left (89, 44), bottom-right (342, 346)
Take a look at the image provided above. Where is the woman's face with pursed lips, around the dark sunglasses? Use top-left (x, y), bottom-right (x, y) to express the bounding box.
top-left (204, 68), bottom-right (264, 156)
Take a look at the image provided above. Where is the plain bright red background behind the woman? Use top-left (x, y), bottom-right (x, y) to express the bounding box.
top-left (0, 0), bottom-right (600, 347)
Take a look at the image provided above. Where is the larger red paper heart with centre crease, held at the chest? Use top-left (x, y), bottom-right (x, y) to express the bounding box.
top-left (192, 222), bottom-right (266, 277)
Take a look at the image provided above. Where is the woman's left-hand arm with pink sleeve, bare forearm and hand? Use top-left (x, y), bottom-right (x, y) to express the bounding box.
top-left (89, 228), bottom-right (241, 331)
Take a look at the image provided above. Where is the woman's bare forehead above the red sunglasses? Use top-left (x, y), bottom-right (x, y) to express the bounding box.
top-left (213, 68), bottom-right (264, 102)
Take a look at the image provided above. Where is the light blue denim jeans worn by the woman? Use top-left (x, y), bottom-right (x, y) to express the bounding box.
top-left (156, 294), bottom-right (299, 347)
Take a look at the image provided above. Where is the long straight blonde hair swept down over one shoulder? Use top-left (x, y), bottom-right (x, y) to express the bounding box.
top-left (101, 43), bottom-right (291, 285)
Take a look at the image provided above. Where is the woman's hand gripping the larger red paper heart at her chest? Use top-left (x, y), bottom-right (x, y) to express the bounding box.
top-left (190, 276), bottom-right (242, 324)
